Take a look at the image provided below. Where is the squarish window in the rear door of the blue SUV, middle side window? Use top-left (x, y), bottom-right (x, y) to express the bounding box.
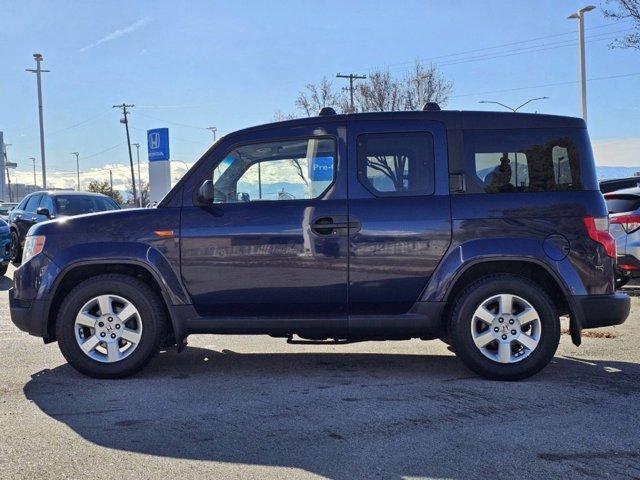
top-left (358, 132), bottom-right (434, 197)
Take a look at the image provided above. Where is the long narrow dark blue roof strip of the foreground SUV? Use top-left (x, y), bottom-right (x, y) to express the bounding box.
top-left (230, 110), bottom-right (586, 135)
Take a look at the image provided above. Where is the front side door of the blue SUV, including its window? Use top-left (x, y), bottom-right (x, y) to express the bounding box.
top-left (181, 122), bottom-right (348, 322)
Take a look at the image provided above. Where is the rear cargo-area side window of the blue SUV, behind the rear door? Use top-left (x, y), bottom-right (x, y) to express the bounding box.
top-left (464, 129), bottom-right (597, 193)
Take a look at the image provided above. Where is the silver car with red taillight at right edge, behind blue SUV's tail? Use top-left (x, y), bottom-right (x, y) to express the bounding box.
top-left (604, 187), bottom-right (640, 288)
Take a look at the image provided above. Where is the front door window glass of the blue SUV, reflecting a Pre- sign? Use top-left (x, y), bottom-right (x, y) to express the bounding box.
top-left (213, 138), bottom-right (335, 203)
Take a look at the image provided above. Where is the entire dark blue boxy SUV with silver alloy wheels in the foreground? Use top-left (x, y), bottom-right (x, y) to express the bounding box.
top-left (10, 107), bottom-right (629, 380)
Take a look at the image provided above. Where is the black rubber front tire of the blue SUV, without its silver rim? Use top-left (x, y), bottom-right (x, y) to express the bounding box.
top-left (56, 274), bottom-right (167, 378)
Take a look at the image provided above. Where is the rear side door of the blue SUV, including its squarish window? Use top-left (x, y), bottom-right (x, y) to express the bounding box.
top-left (348, 120), bottom-right (451, 315)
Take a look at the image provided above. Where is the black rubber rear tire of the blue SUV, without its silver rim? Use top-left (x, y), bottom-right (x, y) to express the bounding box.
top-left (449, 274), bottom-right (560, 380)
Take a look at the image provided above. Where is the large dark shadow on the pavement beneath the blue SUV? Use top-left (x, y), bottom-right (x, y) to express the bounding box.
top-left (24, 348), bottom-right (640, 480)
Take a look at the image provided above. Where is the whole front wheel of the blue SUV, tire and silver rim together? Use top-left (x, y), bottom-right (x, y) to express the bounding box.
top-left (56, 274), bottom-right (166, 378)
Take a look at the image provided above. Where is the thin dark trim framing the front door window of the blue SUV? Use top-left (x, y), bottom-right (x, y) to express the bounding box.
top-left (199, 135), bottom-right (339, 208)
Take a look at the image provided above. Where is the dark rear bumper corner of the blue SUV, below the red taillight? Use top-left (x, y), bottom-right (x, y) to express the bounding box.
top-left (573, 292), bottom-right (631, 328)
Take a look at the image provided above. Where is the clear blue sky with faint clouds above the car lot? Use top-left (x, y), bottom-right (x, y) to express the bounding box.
top-left (0, 0), bottom-right (640, 187)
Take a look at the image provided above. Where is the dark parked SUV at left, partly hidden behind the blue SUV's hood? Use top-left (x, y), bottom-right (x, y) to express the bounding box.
top-left (8, 190), bottom-right (120, 263)
